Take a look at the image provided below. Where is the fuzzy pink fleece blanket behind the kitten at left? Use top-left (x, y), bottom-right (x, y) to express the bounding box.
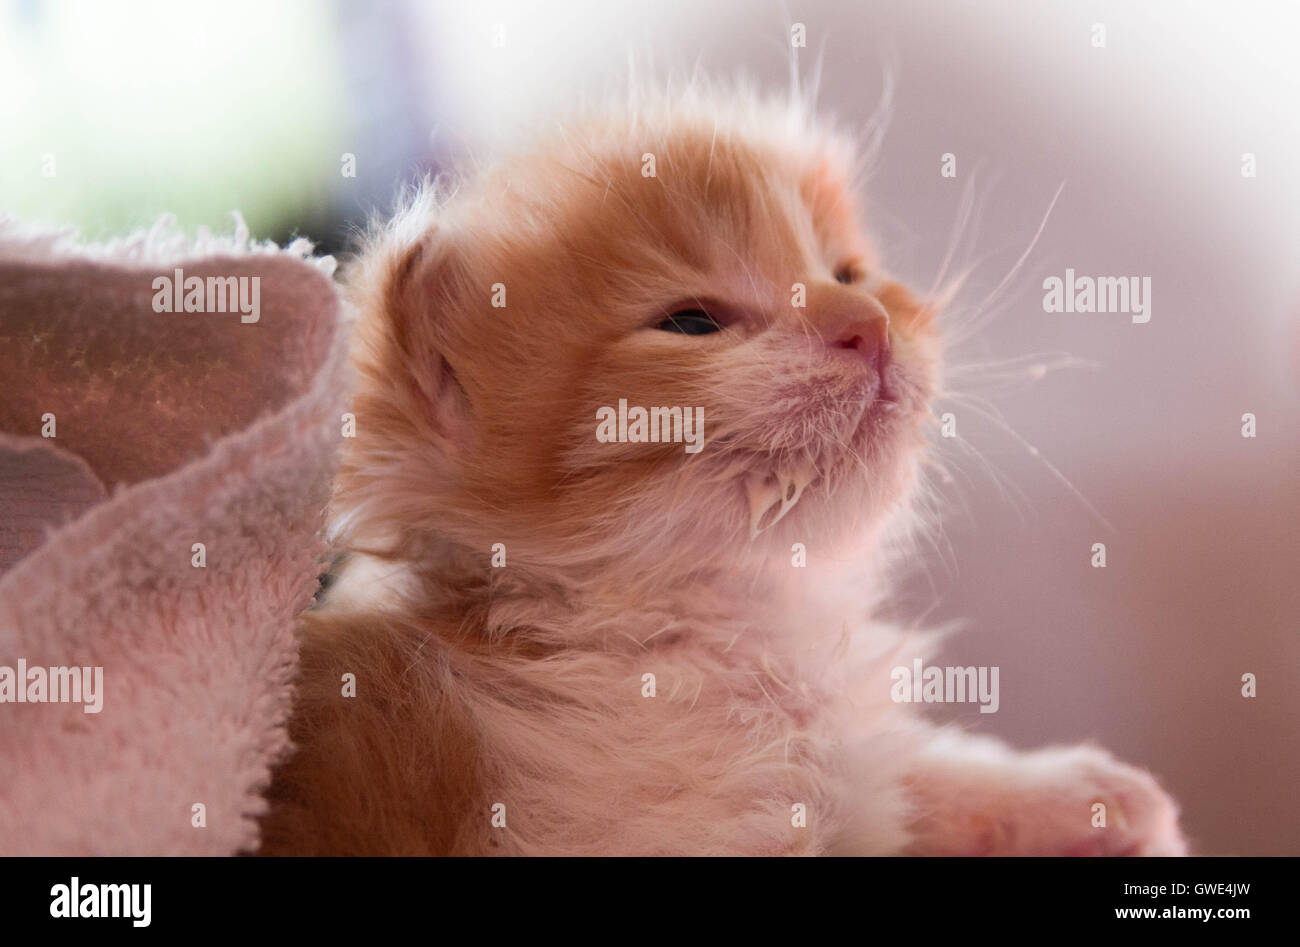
top-left (0, 217), bottom-right (346, 855)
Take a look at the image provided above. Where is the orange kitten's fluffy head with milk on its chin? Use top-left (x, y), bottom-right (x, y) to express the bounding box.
top-left (337, 90), bottom-right (937, 577)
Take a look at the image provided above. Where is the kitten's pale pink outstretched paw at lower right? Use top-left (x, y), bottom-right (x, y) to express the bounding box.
top-left (1018, 747), bottom-right (1187, 856)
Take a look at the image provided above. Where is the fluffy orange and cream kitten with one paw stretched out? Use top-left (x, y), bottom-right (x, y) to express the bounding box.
top-left (263, 94), bottom-right (1184, 855)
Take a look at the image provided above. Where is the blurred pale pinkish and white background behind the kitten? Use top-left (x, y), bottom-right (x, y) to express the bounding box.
top-left (0, 0), bottom-right (1300, 855)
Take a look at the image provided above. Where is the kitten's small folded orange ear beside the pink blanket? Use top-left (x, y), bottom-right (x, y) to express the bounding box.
top-left (384, 228), bottom-right (471, 449)
